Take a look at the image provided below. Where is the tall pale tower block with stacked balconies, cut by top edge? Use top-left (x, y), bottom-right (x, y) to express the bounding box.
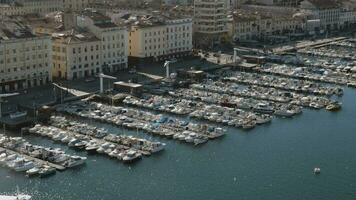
top-left (194, 0), bottom-right (228, 46)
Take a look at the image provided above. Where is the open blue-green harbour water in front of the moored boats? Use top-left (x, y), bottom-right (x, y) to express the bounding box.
top-left (0, 88), bottom-right (356, 200)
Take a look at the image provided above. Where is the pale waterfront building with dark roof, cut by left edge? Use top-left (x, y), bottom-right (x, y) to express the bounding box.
top-left (0, 19), bottom-right (52, 92)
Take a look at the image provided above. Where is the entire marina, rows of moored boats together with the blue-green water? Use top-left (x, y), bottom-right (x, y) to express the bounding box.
top-left (0, 36), bottom-right (356, 200)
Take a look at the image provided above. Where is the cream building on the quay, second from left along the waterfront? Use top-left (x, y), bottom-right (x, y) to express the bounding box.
top-left (52, 31), bottom-right (102, 80)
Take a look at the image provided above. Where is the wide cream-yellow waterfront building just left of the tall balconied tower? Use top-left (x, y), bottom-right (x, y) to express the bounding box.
top-left (125, 16), bottom-right (193, 61)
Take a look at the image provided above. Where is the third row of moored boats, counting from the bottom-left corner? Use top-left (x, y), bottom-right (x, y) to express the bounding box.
top-left (57, 101), bottom-right (224, 145)
